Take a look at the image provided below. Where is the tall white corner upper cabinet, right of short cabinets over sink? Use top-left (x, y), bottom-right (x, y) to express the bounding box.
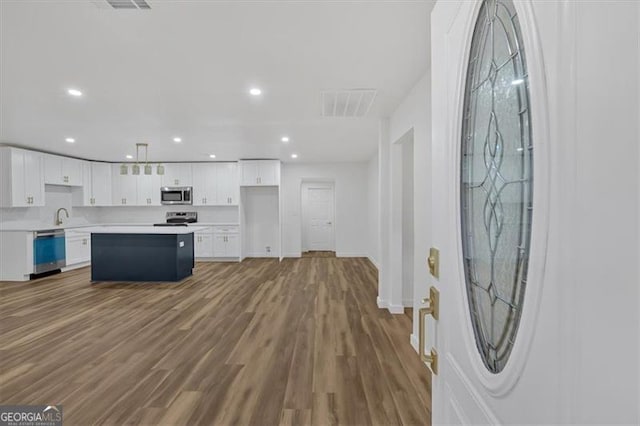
top-left (73, 161), bottom-right (112, 206)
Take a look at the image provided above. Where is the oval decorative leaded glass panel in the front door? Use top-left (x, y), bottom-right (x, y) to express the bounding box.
top-left (460, 0), bottom-right (533, 373)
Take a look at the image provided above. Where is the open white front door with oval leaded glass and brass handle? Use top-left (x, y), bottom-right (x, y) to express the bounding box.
top-left (428, 0), bottom-right (640, 425)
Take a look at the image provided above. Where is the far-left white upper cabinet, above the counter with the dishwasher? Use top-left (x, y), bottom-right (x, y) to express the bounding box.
top-left (0, 147), bottom-right (44, 207)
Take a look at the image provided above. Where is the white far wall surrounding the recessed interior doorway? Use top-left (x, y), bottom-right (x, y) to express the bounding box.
top-left (281, 163), bottom-right (369, 257)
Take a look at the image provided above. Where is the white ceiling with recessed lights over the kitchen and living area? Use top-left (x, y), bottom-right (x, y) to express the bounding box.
top-left (0, 0), bottom-right (435, 162)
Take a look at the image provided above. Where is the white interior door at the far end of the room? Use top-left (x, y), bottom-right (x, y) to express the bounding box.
top-left (302, 184), bottom-right (334, 251)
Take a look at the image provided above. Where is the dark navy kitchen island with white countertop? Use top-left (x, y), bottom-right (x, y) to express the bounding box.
top-left (91, 226), bottom-right (204, 282)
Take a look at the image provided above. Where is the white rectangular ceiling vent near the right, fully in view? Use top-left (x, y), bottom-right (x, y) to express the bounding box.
top-left (322, 89), bottom-right (378, 118)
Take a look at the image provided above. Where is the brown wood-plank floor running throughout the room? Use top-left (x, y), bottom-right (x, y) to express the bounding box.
top-left (0, 257), bottom-right (431, 426)
